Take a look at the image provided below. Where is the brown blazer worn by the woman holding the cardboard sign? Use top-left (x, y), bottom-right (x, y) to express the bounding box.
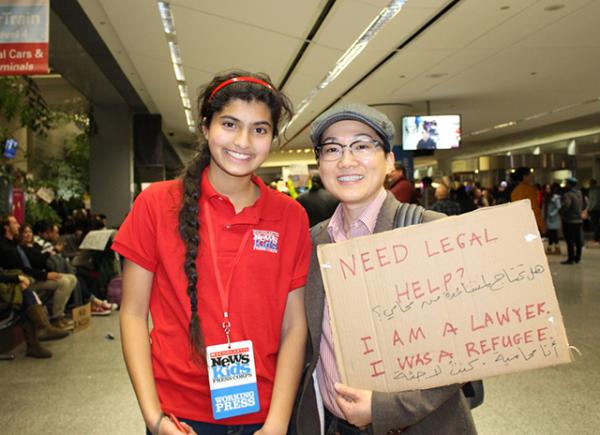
top-left (295, 192), bottom-right (477, 435)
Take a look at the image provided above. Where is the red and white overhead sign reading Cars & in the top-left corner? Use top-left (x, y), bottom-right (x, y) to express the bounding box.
top-left (0, 0), bottom-right (49, 75)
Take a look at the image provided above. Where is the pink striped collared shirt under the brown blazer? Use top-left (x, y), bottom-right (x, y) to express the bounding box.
top-left (317, 188), bottom-right (386, 419)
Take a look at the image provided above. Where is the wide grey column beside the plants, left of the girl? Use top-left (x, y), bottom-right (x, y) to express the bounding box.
top-left (90, 104), bottom-right (134, 227)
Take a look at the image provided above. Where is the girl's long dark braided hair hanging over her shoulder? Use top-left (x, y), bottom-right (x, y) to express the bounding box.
top-left (179, 71), bottom-right (292, 361)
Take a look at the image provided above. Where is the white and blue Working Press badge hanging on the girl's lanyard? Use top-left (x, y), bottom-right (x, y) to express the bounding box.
top-left (206, 340), bottom-right (260, 420)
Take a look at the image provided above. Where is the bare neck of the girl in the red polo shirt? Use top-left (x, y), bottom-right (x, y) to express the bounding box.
top-left (208, 164), bottom-right (260, 213)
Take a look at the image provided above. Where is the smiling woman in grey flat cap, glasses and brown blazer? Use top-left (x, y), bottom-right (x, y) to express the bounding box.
top-left (295, 103), bottom-right (476, 435)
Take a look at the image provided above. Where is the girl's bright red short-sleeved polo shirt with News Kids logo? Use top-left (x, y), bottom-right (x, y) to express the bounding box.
top-left (113, 170), bottom-right (311, 425)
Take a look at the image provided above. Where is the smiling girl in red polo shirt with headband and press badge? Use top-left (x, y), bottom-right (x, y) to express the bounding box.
top-left (113, 72), bottom-right (311, 435)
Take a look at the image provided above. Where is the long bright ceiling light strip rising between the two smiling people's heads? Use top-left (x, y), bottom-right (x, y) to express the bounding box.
top-left (282, 0), bottom-right (407, 133)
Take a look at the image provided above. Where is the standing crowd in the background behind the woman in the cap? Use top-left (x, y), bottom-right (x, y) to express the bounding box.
top-left (297, 163), bottom-right (600, 265)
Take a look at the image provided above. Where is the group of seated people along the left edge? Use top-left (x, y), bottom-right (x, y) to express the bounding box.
top-left (0, 210), bottom-right (118, 358)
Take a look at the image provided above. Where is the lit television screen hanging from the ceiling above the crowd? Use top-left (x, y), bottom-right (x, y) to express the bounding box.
top-left (402, 115), bottom-right (460, 150)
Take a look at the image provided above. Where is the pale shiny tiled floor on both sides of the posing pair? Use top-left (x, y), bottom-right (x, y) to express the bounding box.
top-left (0, 244), bottom-right (600, 435)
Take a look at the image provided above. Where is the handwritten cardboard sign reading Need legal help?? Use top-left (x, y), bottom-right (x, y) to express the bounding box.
top-left (317, 200), bottom-right (571, 392)
